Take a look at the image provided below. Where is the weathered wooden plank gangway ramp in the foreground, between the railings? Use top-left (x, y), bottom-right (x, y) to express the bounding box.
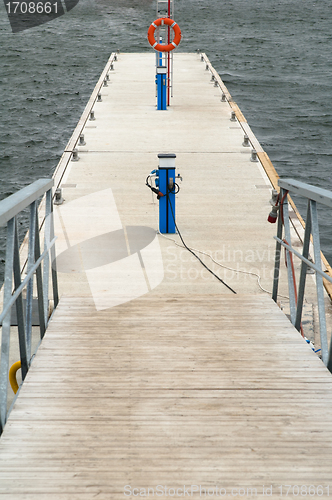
top-left (0, 294), bottom-right (332, 500)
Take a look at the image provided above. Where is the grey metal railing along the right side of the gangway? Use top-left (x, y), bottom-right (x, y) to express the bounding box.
top-left (272, 179), bottom-right (332, 372)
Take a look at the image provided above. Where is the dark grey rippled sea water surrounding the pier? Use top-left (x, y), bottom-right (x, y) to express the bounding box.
top-left (0, 0), bottom-right (332, 280)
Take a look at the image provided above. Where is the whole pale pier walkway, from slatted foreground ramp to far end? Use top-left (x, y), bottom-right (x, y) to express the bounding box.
top-left (0, 53), bottom-right (332, 494)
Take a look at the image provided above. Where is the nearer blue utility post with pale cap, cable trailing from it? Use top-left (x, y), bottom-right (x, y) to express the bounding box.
top-left (158, 153), bottom-right (176, 234)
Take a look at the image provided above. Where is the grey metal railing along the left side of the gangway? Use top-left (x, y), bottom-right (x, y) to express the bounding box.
top-left (0, 179), bottom-right (59, 434)
